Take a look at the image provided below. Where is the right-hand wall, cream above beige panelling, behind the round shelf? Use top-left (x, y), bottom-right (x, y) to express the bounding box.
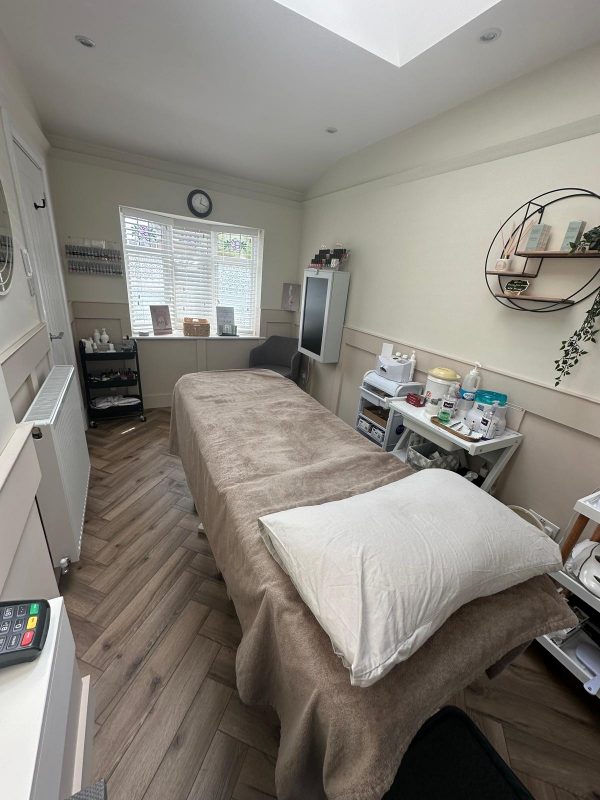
top-left (300, 47), bottom-right (600, 525)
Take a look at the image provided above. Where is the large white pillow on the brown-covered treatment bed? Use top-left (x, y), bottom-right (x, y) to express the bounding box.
top-left (259, 469), bottom-right (562, 686)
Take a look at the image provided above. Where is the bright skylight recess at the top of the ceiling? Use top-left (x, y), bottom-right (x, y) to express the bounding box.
top-left (275, 0), bottom-right (499, 67)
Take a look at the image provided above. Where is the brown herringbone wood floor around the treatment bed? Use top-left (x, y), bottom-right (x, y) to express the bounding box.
top-left (61, 410), bottom-right (600, 800)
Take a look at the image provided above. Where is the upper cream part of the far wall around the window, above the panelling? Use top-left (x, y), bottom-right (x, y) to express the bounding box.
top-left (49, 150), bottom-right (301, 309)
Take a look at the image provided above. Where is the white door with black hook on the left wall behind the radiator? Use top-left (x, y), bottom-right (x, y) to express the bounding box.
top-left (14, 139), bottom-right (77, 367)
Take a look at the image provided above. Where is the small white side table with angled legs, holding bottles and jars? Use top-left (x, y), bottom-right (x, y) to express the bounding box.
top-left (388, 399), bottom-right (523, 492)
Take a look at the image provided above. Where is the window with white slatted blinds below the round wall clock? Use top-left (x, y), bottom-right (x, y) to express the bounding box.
top-left (120, 207), bottom-right (263, 336)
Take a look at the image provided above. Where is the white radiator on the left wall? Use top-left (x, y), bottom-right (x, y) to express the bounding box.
top-left (23, 366), bottom-right (90, 571)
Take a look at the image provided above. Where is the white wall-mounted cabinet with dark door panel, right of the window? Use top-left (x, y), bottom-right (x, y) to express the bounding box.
top-left (298, 269), bottom-right (350, 364)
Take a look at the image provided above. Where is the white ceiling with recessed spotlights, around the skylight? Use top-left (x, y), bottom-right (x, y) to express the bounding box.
top-left (0, 0), bottom-right (600, 191)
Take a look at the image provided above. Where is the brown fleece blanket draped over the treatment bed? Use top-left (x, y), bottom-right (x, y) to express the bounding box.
top-left (171, 370), bottom-right (573, 800)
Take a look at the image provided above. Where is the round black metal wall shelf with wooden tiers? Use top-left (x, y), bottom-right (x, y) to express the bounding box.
top-left (485, 187), bottom-right (600, 314)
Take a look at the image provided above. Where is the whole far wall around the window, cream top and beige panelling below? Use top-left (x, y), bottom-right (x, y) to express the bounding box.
top-left (49, 148), bottom-right (301, 407)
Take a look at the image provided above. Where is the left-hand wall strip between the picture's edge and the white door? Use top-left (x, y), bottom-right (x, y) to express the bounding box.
top-left (0, 35), bottom-right (49, 420)
